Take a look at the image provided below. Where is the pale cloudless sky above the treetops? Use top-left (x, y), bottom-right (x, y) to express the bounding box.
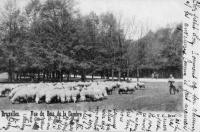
top-left (0, 0), bottom-right (183, 38)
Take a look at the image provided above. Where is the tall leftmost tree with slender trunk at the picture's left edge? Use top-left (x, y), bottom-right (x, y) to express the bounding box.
top-left (1, 0), bottom-right (21, 82)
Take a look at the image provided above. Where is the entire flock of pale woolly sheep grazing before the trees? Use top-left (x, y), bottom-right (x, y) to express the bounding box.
top-left (0, 81), bottom-right (145, 103)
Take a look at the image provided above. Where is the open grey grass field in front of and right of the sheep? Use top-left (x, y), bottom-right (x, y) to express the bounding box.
top-left (0, 82), bottom-right (183, 111)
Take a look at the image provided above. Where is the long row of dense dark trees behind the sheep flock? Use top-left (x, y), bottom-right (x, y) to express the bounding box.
top-left (0, 0), bottom-right (182, 82)
